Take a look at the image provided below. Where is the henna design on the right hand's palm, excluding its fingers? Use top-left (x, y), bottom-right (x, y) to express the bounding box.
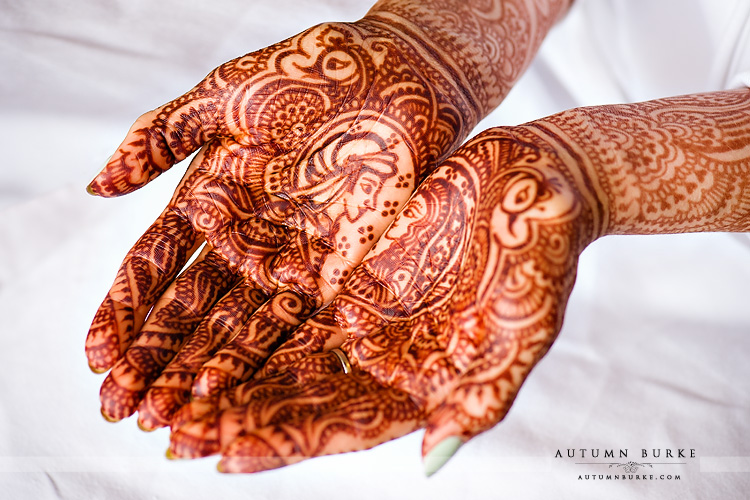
top-left (336, 131), bottom-right (593, 411)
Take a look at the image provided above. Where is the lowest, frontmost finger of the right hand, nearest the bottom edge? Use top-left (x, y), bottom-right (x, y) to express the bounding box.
top-left (218, 375), bottom-right (422, 473)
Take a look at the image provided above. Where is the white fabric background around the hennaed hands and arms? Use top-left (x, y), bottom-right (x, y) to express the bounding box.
top-left (0, 0), bottom-right (750, 500)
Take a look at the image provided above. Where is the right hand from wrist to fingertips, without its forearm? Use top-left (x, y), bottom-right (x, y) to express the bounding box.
top-left (167, 130), bottom-right (592, 471)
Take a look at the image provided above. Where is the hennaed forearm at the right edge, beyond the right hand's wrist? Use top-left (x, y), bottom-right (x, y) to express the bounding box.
top-left (525, 89), bottom-right (750, 235)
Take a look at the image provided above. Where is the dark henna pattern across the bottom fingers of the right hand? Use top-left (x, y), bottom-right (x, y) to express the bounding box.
top-left (170, 369), bottom-right (423, 472)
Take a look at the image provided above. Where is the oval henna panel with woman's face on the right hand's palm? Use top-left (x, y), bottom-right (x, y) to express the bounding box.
top-left (336, 169), bottom-right (474, 342)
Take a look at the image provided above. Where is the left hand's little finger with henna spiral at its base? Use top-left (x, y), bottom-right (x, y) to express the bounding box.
top-left (193, 290), bottom-right (315, 398)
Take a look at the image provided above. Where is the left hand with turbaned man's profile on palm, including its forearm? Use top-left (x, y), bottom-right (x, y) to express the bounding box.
top-left (86, 0), bottom-right (569, 429)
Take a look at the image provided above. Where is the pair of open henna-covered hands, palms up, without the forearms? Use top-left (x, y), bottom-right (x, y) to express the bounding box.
top-left (86, 2), bottom-right (581, 471)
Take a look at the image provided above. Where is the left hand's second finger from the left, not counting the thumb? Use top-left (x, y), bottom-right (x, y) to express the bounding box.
top-left (100, 247), bottom-right (237, 420)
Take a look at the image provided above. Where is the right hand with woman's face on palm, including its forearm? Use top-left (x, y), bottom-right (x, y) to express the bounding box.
top-left (170, 89), bottom-right (750, 472)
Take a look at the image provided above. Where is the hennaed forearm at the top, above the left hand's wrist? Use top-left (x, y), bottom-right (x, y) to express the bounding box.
top-left (363, 0), bottom-right (573, 124)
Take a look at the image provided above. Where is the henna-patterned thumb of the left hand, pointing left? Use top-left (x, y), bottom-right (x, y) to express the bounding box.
top-left (87, 71), bottom-right (225, 197)
